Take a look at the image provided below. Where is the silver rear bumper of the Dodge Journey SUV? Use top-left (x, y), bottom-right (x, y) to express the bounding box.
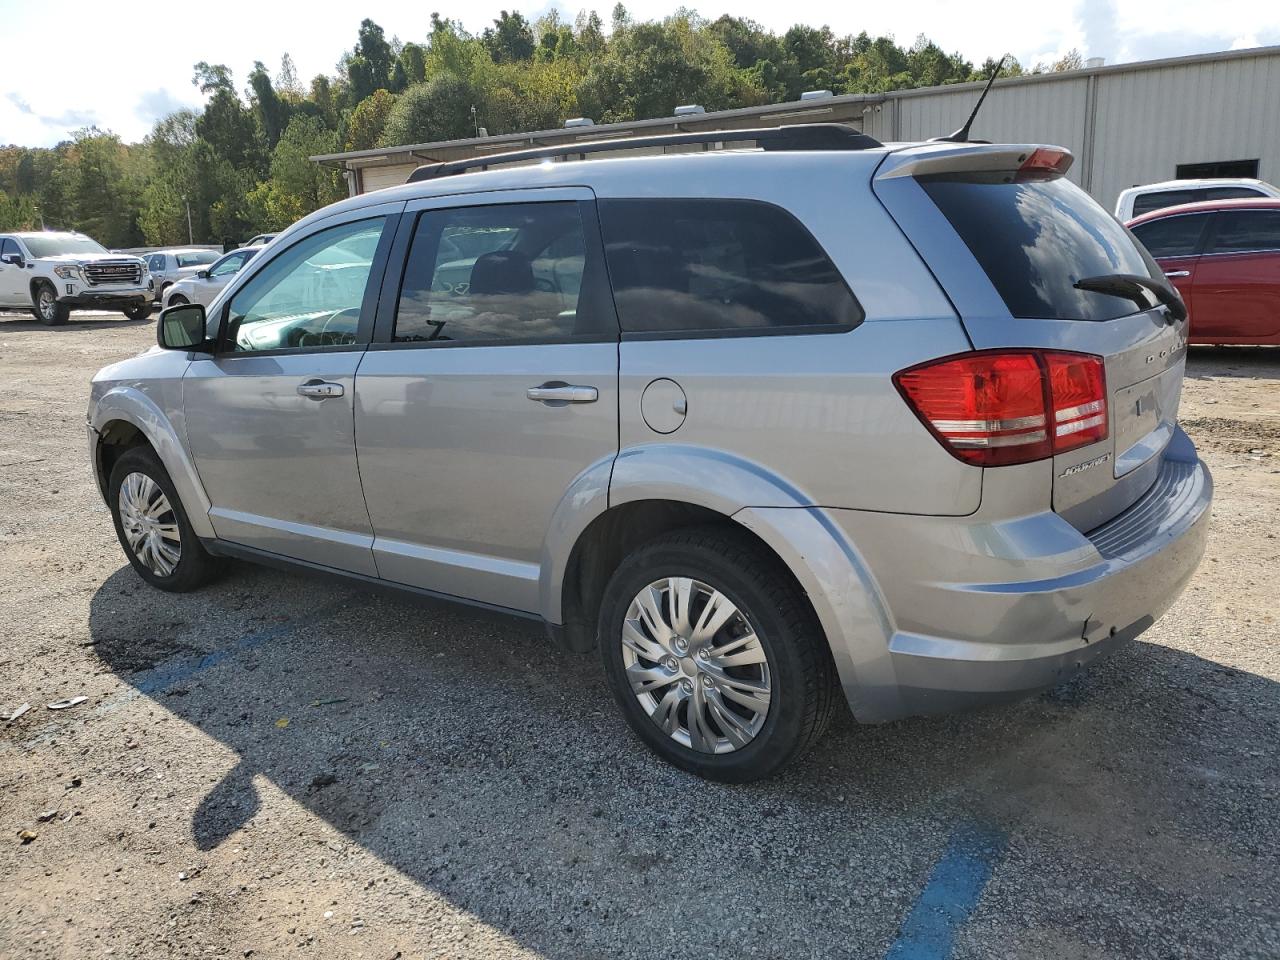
top-left (831, 430), bottom-right (1213, 722)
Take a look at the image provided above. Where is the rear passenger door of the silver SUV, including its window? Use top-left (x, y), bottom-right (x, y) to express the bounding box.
top-left (356, 188), bottom-right (618, 612)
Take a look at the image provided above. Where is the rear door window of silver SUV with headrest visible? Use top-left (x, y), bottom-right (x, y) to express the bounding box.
top-left (394, 201), bottom-right (616, 344)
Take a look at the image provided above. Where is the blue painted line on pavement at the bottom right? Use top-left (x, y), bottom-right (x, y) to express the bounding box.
top-left (884, 823), bottom-right (1007, 960)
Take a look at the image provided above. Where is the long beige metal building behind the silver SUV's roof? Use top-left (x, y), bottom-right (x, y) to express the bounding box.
top-left (312, 46), bottom-right (1280, 209)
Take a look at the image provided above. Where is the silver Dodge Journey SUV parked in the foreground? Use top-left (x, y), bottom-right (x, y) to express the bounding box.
top-left (88, 125), bottom-right (1212, 781)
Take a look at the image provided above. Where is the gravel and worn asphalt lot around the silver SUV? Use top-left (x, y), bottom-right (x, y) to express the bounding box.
top-left (0, 315), bottom-right (1280, 960)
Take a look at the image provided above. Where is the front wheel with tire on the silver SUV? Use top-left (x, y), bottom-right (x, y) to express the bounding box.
top-left (108, 447), bottom-right (218, 593)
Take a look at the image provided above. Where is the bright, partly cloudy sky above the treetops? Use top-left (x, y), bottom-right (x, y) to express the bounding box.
top-left (0, 0), bottom-right (1280, 146)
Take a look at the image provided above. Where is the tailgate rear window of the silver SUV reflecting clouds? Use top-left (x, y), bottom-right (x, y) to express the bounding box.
top-left (920, 177), bottom-right (1162, 320)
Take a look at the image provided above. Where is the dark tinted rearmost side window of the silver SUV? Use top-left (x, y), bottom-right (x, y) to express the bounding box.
top-left (599, 200), bottom-right (863, 334)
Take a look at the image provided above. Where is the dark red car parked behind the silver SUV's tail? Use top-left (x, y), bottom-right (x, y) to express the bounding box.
top-left (1128, 198), bottom-right (1280, 344)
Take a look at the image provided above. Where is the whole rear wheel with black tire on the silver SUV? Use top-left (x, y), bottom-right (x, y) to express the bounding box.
top-left (599, 527), bottom-right (837, 782)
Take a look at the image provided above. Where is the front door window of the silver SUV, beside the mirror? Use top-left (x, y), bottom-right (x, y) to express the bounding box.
top-left (224, 218), bottom-right (385, 352)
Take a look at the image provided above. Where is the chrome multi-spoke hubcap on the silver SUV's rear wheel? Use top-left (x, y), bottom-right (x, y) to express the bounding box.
top-left (622, 577), bottom-right (772, 754)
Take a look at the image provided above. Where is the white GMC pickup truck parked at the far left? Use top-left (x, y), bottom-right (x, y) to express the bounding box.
top-left (0, 230), bottom-right (155, 326)
